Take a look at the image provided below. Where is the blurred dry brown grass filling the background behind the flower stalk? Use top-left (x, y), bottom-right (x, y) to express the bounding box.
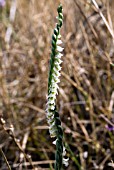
top-left (0, 0), bottom-right (114, 170)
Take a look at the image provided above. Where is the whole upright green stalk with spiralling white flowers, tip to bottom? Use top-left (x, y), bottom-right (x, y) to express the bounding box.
top-left (46, 5), bottom-right (68, 170)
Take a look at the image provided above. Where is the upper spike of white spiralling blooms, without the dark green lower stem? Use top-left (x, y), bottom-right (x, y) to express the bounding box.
top-left (47, 5), bottom-right (63, 137)
